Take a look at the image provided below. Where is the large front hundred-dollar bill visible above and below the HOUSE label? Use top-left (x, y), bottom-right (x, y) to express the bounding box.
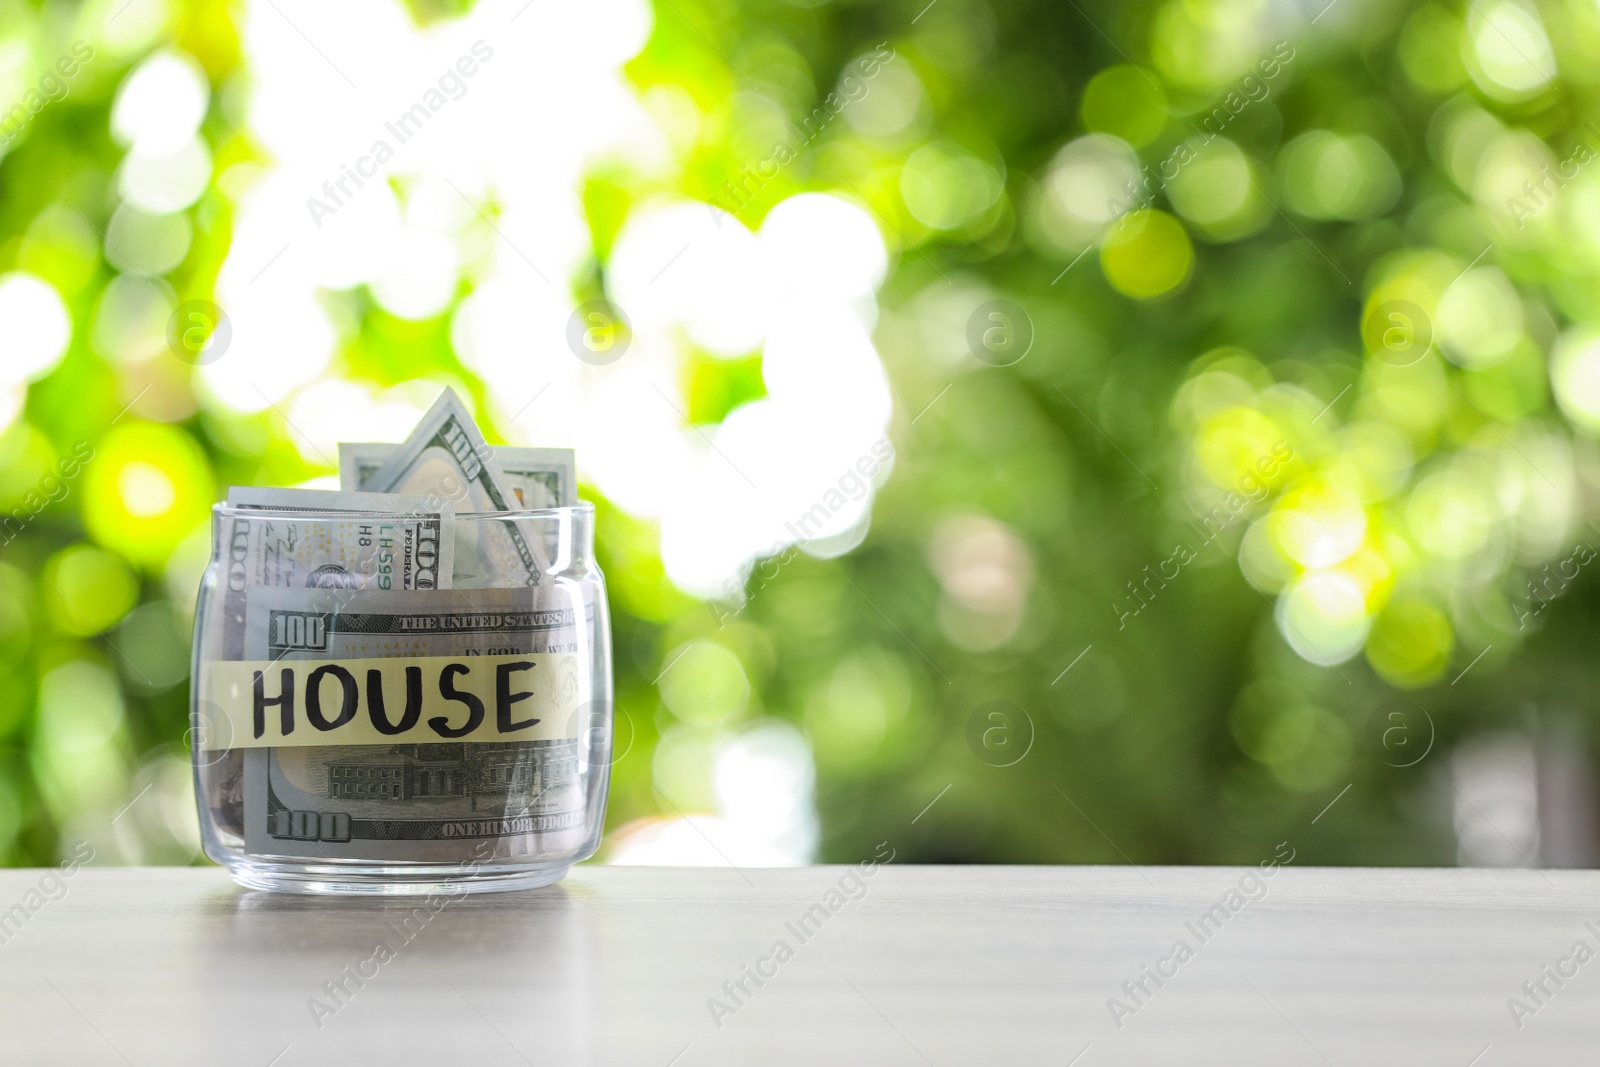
top-left (245, 585), bottom-right (594, 862)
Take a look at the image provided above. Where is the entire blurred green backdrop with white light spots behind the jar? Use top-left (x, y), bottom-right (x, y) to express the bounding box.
top-left (0, 0), bottom-right (1600, 865)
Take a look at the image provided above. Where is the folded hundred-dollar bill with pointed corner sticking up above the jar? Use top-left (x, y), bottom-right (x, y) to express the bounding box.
top-left (356, 389), bottom-right (550, 589)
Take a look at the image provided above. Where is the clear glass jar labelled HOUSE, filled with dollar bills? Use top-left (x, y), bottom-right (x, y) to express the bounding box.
top-left (190, 504), bottom-right (611, 894)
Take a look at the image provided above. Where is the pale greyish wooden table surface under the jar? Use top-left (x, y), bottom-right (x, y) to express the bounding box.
top-left (0, 864), bottom-right (1600, 1067)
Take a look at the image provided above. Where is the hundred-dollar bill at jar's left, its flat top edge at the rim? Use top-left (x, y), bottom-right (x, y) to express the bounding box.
top-left (205, 488), bottom-right (456, 833)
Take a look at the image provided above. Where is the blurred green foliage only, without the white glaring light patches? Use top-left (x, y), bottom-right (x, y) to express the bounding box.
top-left (0, 0), bottom-right (1600, 864)
